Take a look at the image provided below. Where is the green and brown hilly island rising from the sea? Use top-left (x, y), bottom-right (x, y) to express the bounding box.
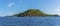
top-left (13, 9), bottom-right (58, 17)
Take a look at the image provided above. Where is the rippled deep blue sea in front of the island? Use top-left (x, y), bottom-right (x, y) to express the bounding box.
top-left (0, 17), bottom-right (60, 26)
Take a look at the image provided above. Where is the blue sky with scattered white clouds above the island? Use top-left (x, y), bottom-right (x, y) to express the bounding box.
top-left (0, 0), bottom-right (60, 16)
